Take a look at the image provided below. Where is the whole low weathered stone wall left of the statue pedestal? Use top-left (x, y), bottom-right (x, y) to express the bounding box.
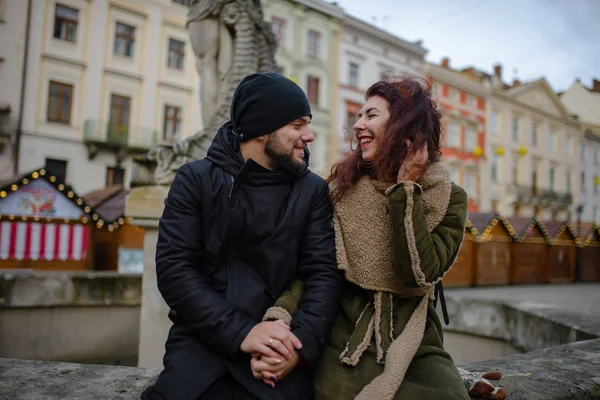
top-left (0, 271), bottom-right (142, 365)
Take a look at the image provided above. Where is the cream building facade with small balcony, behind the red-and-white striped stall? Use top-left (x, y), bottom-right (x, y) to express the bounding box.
top-left (2, 0), bottom-right (202, 193)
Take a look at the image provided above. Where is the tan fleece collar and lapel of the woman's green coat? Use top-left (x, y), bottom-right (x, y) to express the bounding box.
top-left (334, 163), bottom-right (452, 297)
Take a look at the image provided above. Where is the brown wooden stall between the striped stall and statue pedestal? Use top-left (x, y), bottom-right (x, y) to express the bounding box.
top-left (83, 185), bottom-right (144, 273)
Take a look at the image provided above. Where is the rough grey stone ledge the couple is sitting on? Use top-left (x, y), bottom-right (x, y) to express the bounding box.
top-left (0, 339), bottom-right (600, 400)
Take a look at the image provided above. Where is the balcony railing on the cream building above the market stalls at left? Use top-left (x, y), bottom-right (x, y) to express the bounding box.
top-left (83, 120), bottom-right (157, 150)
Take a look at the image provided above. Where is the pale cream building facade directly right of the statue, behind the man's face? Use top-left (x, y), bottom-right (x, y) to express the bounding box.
top-left (262, 0), bottom-right (344, 176)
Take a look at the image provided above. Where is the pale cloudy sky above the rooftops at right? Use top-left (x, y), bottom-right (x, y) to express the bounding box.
top-left (338, 0), bottom-right (600, 91)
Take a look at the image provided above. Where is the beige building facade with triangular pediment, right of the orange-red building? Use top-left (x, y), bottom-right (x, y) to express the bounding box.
top-left (485, 66), bottom-right (581, 219)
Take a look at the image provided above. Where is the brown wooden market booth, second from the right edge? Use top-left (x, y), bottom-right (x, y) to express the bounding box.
top-left (542, 221), bottom-right (579, 283)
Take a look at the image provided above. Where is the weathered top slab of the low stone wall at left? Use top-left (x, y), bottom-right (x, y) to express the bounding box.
top-left (0, 270), bottom-right (142, 308)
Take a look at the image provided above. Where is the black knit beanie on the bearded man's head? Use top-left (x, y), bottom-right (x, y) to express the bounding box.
top-left (230, 72), bottom-right (312, 142)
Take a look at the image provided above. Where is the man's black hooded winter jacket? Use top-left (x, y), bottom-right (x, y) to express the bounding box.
top-left (156, 124), bottom-right (343, 398)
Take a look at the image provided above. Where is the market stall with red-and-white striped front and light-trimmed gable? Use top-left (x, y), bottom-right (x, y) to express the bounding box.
top-left (0, 168), bottom-right (95, 270)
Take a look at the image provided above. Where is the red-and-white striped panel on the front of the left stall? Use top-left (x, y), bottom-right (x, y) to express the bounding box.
top-left (0, 222), bottom-right (89, 260)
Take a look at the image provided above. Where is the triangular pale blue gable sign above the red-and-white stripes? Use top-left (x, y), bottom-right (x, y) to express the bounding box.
top-left (0, 179), bottom-right (83, 219)
